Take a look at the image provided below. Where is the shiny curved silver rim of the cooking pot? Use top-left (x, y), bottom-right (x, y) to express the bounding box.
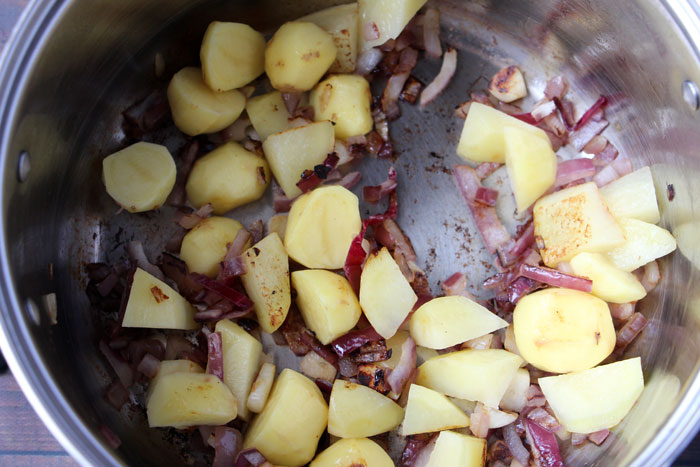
top-left (0, 0), bottom-right (700, 466)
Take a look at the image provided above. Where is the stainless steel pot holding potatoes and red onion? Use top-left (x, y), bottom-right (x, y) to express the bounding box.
top-left (0, 0), bottom-right (700, 466)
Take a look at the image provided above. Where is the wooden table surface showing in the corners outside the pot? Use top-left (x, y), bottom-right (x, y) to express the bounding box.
top-left (0, 0), bottom-right (700, 467)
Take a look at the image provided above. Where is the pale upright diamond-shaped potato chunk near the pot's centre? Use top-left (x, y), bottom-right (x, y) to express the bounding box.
top-left (360, 248), bottom-right (418, 339)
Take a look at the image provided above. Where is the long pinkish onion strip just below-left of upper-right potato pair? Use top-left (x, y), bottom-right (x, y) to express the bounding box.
top-left (454, 165), bottom-right (511, 253)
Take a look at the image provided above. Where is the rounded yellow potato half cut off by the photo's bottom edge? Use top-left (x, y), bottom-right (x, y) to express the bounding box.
top-left (309, 438), bottom-right (394, 467)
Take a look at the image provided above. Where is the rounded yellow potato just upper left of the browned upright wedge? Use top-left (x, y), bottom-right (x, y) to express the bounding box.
top-left (180, 216), bottom-right (250, 277)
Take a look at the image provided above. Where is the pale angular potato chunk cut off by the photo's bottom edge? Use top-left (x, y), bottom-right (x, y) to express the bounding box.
top-left (426, 431), bottom-right (486, 467)
